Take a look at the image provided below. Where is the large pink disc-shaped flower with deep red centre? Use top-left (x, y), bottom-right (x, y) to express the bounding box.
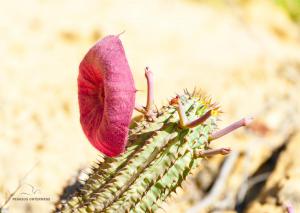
top-left (77, 35), bottom-right (136, 157)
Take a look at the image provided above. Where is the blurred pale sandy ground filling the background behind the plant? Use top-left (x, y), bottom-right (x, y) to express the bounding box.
top-left (0, 0), bottom-right (300, 213)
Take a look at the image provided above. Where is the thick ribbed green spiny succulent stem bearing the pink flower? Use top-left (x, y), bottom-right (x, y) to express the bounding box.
top-left (57, 91), bottom-right (219, 212)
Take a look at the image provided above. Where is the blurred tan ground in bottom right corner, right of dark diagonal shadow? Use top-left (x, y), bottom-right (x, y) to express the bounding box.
top-left (247, 132), bottom-right (300, 213)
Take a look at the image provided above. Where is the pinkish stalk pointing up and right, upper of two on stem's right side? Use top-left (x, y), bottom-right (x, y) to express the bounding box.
top-left (208, 117), bottom-right (253, 141)
